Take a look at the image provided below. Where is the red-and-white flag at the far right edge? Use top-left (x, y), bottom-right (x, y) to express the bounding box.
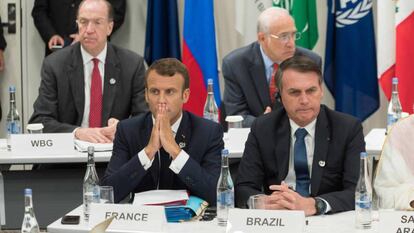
top-left (377, 0), bottom-right (414, 113)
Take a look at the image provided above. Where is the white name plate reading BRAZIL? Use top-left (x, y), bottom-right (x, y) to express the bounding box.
top-left (226, 209), bottom-right (305, 233)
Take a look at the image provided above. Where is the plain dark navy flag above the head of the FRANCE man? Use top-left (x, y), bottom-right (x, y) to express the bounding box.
top-left (144, 0), bottom-right (181, 65)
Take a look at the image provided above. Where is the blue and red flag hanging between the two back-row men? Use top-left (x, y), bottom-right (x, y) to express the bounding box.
top-left (183, 0), bottom-right (221, 116)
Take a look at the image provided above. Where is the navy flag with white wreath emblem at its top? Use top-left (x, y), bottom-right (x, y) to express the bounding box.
top-left (324, 0), bottom-right (379, 121)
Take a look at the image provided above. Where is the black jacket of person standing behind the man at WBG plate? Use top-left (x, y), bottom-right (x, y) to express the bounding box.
top-left (32, 0), bottom-right (126, 55)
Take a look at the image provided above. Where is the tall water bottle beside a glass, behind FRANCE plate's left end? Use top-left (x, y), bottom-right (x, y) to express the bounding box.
top-left (83, 146), bottom-right (100, 222)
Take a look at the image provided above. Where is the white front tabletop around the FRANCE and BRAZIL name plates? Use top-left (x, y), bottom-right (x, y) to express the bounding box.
top-left (47, 206), bottom-right (379, 233)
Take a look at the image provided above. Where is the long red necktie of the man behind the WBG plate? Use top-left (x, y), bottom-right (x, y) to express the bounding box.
top-left (89, 58), bottom-right (102, 128)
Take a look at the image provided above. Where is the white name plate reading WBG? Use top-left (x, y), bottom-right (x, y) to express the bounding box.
top-left (10, 133), bottom-right (75, 156)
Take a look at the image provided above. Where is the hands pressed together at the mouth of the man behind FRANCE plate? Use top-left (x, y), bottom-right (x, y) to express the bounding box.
top-left (145, 104), bottom-right (181, 160)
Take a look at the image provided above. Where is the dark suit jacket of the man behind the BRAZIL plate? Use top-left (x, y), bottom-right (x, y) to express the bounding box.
top-left (235, 105), bottom-right (365, 213)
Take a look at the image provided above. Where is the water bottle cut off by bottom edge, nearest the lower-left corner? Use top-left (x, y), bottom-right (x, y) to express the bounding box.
top-left (21, 189), bottom-right (40, 233)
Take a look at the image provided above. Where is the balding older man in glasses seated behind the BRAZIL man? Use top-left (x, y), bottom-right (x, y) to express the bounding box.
top-left (222, 7), bottom-right (321, 127)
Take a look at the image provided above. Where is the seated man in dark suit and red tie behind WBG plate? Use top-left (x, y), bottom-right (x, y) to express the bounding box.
top-left (29, 0), bottom-right (148, 143)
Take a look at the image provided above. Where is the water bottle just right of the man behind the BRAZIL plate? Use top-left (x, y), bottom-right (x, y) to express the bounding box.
top-left (355, 152), bottom-right (372, 229)
